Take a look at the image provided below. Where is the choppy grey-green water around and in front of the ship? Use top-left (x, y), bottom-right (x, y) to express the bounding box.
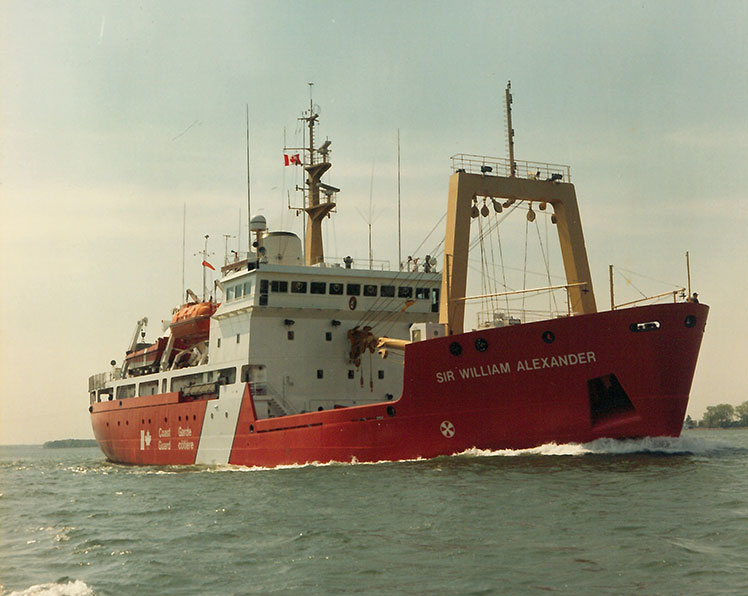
top-left (0, 430), bottom-right (748, 596)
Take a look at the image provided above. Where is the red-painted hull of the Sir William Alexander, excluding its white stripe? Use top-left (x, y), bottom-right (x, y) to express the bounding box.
top-left (91, 303), bottom-right (709, 467)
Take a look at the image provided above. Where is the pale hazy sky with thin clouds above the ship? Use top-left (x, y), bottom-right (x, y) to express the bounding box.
top-left (0, 0), bottom-right (748, 444)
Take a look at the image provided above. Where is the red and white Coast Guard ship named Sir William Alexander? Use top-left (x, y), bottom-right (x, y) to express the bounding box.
top-left (88, 87), bottom-right (709, 468)
